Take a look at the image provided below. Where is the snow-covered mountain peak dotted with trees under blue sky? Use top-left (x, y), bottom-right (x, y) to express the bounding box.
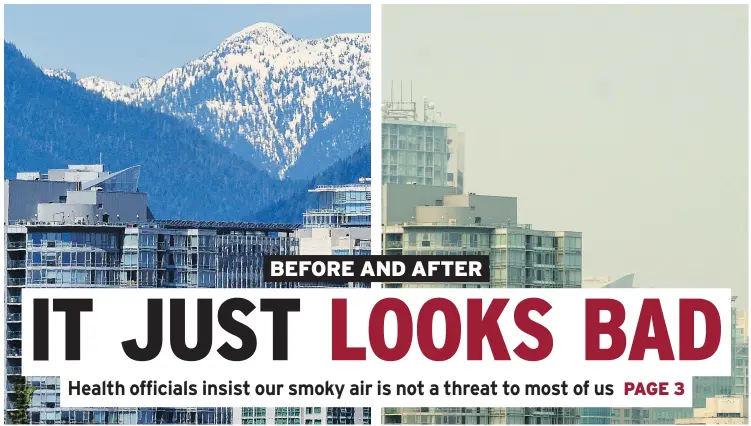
top-left (45, 23), bottom-right (370, 177)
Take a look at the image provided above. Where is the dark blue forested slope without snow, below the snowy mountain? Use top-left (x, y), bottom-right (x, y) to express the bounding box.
top-left (4, 42), bottom-right (370, 222)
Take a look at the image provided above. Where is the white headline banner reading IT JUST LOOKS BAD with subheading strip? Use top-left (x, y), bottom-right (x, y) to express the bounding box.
top-left (22, 288), bottom-right (731, 407)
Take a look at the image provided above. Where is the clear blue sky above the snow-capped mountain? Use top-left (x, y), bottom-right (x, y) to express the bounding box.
top-left (5, 5), bottom-right (370, 84)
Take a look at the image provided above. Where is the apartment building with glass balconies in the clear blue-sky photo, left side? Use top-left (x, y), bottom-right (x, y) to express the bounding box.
top-left (5, 165), bottom-right (299, 424)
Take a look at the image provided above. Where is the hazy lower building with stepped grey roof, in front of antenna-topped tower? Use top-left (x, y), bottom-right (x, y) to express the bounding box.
top-left (382, 185), bottom-right (582, 288)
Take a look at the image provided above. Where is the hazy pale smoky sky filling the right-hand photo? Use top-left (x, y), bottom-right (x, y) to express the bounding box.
top-left (383, 5), bottom-right (748, 304)
